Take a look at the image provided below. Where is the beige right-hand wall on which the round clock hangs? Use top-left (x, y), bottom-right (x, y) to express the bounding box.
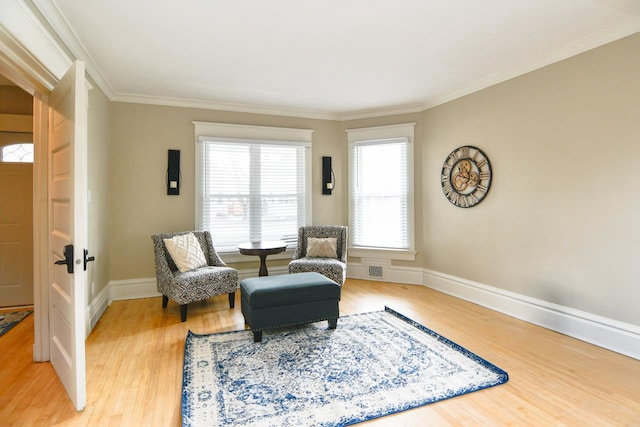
top-left (420, 34), bottom-right (640, 325)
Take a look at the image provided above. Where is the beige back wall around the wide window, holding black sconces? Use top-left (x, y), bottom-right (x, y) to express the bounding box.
top-left (109, 103), bottom-right (346, 280)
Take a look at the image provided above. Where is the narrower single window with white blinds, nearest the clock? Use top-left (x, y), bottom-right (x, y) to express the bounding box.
top-left (347, 123), bottom-right (415, 259)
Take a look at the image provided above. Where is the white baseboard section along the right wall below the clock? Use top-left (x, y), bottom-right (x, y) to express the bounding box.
top-left (423, 269), bottom-right (640, 359)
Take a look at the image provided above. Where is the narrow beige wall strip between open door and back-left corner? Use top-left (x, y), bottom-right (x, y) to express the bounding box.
top-left (87, 80), bottom-right (112, 301)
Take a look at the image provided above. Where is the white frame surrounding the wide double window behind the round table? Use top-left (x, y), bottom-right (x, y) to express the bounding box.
top-left (193, 121), bottom-right (313, 262)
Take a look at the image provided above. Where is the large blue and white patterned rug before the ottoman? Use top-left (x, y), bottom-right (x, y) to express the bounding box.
top-left (182, 307), bottom-right (509, 426)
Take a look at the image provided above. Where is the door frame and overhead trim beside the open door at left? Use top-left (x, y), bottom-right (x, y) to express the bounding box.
top-left (0, 0), bottom-right (73, 362)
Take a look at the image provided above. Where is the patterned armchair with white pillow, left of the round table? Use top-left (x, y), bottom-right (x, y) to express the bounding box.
top-left (151, 231), bottom-right (239, 322)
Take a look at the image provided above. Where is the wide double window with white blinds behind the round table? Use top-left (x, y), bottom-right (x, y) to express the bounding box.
top-left (196, 123), bottom-right (311, 252)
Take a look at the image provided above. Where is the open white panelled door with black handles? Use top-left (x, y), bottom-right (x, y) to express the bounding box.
top-left (48, 61), bottom-right (87, 411)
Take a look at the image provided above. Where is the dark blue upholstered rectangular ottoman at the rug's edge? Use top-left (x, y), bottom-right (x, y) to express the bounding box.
top-left (240, 273), bottom-right (340, 342)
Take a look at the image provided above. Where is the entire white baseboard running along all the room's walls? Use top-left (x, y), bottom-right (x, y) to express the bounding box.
top-left (87, 270), bottom-right (640, 360)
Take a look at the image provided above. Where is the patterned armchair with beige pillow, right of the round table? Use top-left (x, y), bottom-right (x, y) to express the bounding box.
top-left (289, 225), bottom-right (347, 285)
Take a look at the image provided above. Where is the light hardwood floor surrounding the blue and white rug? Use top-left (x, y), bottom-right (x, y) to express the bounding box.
top-left (0, 280), bottom-right (640, 426)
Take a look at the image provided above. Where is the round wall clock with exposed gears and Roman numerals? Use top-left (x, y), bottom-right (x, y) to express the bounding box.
top-left (441, 145), bottom-right (491, 208)
